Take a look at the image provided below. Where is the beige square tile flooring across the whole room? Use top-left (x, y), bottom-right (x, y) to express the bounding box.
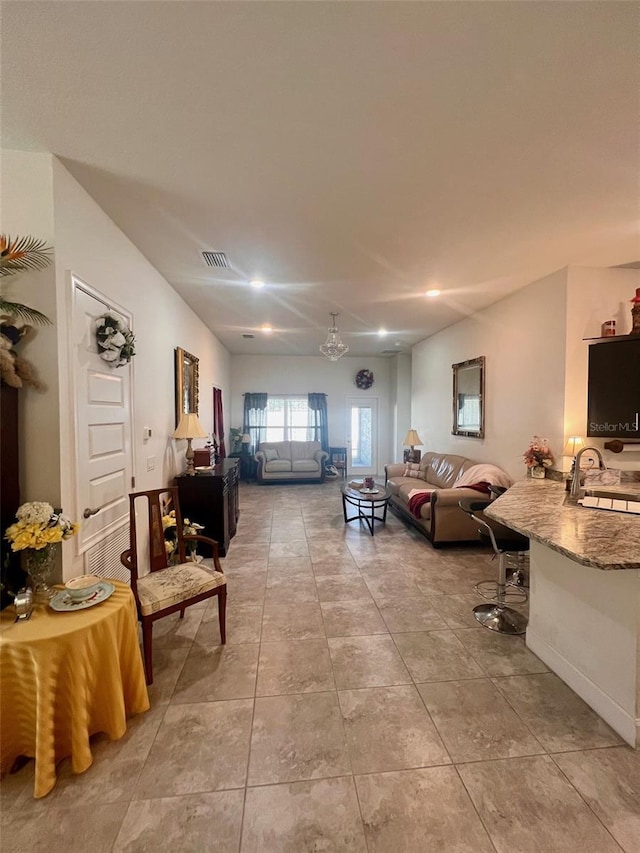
top-left (0, 482), bottom-right (640, 853)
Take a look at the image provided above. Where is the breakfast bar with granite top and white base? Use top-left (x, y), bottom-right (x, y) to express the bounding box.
top-left (485, 479), bottom-right (640, 748)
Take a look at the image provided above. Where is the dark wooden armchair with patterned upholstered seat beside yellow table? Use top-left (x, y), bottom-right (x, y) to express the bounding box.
top-left (120, 486), bottom-right (227, 684)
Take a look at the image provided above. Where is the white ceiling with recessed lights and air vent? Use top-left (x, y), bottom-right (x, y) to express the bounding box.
top-left (1, 0), bottom-right (640, 356)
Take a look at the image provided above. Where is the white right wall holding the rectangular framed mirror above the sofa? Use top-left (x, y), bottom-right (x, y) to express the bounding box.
top-left (412, 270), bottom-right (567, 479)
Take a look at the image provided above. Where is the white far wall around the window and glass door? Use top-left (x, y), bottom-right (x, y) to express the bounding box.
top-left (229, 355), bottom-right (394, 472)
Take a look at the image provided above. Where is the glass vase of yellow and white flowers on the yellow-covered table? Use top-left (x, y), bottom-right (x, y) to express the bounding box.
top-left (5, 501), bottom-right (78, 602)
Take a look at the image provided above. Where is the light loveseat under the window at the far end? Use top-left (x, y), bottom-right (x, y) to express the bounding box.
top-left (255, 441), bottom-right (329, 484)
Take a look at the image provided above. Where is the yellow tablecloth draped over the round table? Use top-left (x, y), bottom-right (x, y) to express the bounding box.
top-left (0, 581), bottom-right (149, 797)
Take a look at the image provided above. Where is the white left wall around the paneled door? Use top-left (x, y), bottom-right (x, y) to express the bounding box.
top-left (2, 151), bottom-right (230, 576)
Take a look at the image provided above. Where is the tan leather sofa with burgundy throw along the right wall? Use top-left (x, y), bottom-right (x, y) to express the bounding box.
top-left (385, 452), bottom-right (513, 548)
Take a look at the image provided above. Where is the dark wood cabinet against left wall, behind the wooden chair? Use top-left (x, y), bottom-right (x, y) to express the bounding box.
top-left (174, 459), bottom-right (240, 557)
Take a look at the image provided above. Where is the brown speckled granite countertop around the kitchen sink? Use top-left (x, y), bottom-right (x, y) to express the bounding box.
top-left (485, 479), bottom-right (640, 569)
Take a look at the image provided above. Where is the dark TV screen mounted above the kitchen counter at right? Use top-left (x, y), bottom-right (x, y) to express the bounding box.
top-left (587, 336), bottom-right (640, 439)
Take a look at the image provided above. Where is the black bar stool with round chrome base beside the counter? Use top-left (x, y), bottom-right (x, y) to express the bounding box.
top-left (459, 498), bottom-right (529, 634)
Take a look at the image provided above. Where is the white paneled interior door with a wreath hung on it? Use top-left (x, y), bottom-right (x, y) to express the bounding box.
top-left (71, 276), bottom-right (134, 553)
